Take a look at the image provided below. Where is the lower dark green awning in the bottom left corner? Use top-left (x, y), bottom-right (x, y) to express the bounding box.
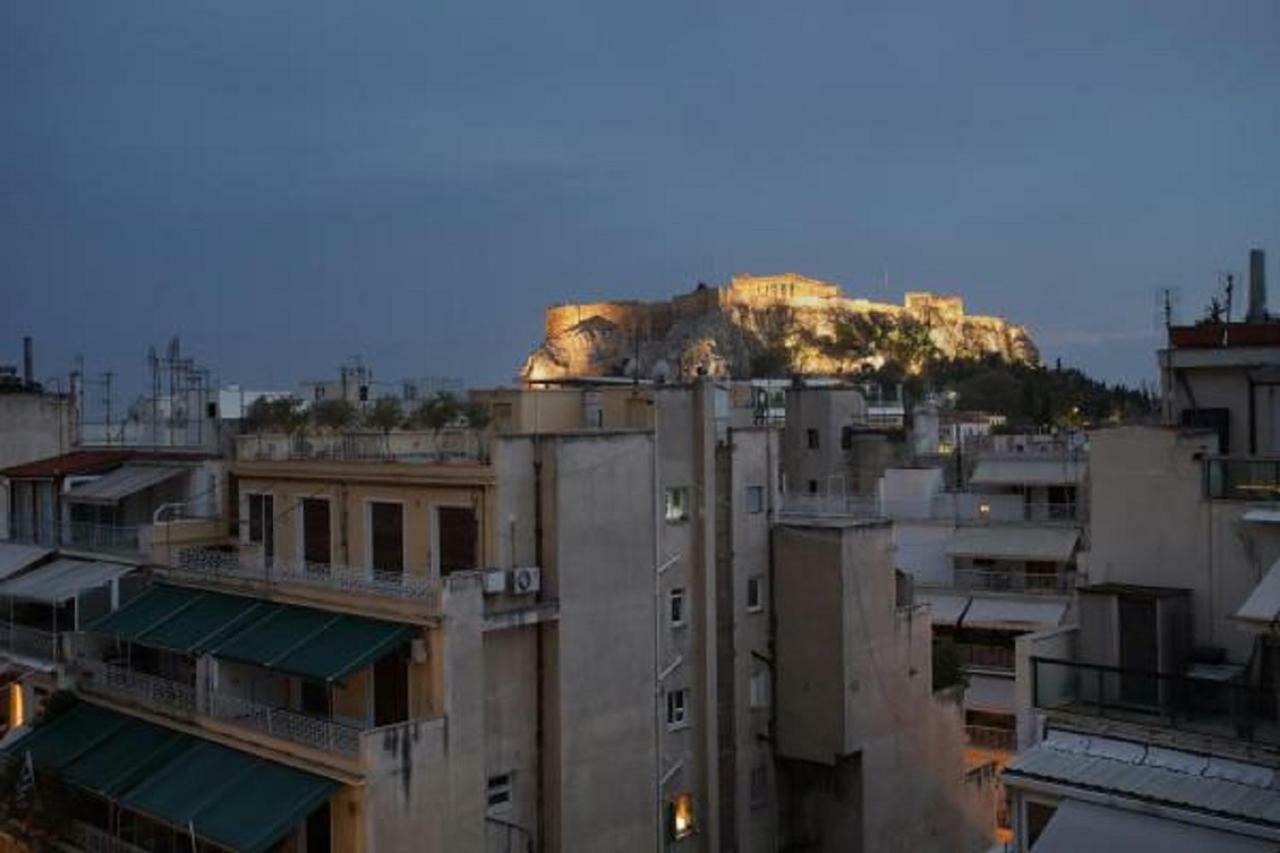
top-left (5, 702), bottom-right (338, 853)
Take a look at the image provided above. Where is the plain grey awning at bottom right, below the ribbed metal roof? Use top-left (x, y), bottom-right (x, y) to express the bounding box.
top-left (1032, 799), bottom-right (1276, 853)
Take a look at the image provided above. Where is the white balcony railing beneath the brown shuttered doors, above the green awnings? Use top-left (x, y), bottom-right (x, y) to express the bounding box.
top-left (170, 547), bottom-right (440, 610)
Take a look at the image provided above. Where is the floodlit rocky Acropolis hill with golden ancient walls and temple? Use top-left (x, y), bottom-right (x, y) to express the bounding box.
top-left (522, 273), bottom-right (1039, 382)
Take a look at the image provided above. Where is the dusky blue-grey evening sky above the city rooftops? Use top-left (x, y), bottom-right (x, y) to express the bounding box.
top-left (0, 0), bottom-right (1280, 388)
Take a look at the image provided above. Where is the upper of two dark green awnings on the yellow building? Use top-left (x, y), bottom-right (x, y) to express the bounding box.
top-left (88, 584), bottom-right (417, 681)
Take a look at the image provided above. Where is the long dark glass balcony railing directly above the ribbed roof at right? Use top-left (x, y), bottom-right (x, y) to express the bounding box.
top-left (1032, 657), bottom-right (1280, 747)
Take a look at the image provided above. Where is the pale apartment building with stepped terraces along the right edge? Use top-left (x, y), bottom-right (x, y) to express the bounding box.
top-left (1004, 252), bottom-right (1280, 852)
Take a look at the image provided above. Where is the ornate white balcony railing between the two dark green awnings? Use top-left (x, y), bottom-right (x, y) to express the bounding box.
top-left (74, 658), bottom-right (362, 756)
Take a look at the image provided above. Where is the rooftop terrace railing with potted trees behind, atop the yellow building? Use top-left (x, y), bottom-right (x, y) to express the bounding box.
top-left (236, 428), bottom-right (488, 462)
